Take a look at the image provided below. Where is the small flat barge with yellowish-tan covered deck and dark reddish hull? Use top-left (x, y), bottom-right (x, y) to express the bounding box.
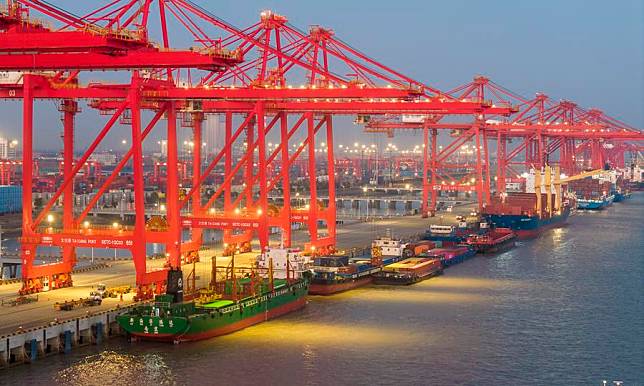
top-left (373, 257), bottom-right (443, 285)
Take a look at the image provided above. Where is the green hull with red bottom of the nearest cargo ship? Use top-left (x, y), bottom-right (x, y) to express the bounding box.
top-left (117, 282), bottom-right (308, 343)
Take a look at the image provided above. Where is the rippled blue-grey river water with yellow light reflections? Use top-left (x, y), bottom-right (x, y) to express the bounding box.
top-left (0, 194), bottom-right (644, 386)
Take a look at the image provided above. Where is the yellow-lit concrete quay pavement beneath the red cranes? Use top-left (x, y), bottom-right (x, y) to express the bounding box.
top-left (0, 205), bottom-right (472, 335)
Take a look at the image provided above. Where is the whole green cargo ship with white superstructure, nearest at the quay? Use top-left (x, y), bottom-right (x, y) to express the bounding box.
top-left (117, 253), bottom-right (309, 343)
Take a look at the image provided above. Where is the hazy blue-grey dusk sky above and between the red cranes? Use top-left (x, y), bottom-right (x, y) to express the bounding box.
top-left (0, 0), bottom-right (644, 149)
